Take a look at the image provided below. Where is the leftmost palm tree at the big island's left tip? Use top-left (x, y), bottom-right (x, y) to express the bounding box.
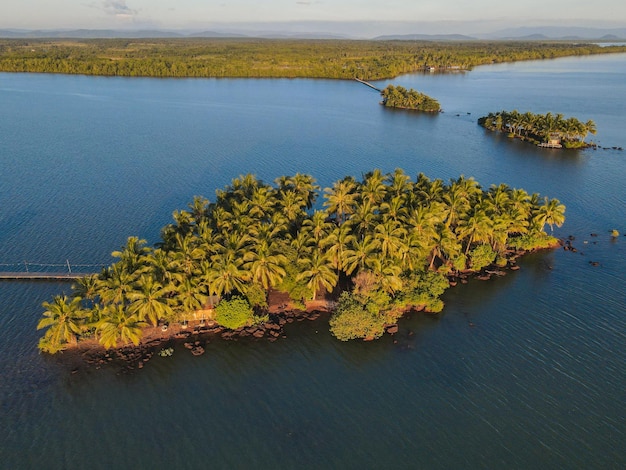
top-left (37, 295), bottom-right (86, 353)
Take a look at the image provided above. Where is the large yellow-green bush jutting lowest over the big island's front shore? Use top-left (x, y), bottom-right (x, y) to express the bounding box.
top-left (330, 292), bottom-right (385, 341)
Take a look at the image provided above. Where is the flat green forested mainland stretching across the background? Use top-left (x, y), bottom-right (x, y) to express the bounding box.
top-left (0, 38), bottom-right (626, 80)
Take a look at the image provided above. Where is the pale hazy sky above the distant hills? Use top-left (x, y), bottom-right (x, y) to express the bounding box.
top-left (0, 0), bottom-right (626, 36)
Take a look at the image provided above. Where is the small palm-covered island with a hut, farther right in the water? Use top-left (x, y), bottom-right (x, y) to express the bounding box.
top-left (478, 110), bottom-right (596, 149)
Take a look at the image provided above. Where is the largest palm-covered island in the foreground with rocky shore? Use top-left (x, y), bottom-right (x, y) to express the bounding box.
top-left (37, 169), bottom-right (565, 365)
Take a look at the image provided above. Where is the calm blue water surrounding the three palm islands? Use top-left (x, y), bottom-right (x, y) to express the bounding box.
top-left (0, 55), bottom-right (626, 469)
